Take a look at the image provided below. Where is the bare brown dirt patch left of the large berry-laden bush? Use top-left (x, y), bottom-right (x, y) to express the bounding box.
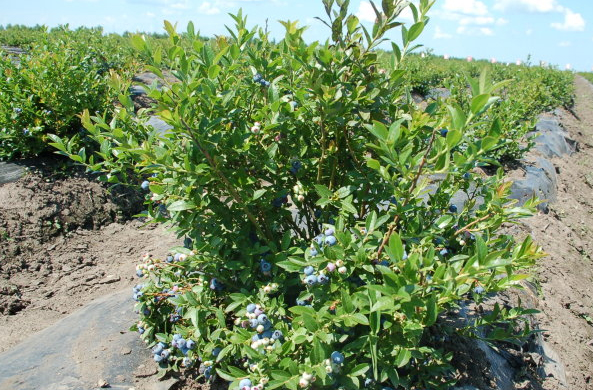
top-left (0, 163), bottom-right (179, 352)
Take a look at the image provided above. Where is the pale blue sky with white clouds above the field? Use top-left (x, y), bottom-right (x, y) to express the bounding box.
top-left (0, 0), bottom-right (593, 71)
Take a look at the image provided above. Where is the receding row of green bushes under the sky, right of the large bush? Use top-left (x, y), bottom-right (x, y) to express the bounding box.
top-left (381, 54), bottom-right (574, 162)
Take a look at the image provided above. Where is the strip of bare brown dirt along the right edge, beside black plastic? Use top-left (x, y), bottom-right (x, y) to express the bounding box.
top-left (524, 76), bottom-right (593, 390)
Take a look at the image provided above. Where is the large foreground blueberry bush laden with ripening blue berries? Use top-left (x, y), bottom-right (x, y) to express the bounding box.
top-left (52, 0), bottom-right (541, 390)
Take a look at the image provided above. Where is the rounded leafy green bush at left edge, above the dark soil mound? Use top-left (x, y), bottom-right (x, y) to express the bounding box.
top-left (0, 28), bottom-right (135, 159)
